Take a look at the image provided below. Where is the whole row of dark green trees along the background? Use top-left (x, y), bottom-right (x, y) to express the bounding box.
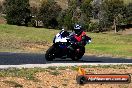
top-left (0, 0), bottom-right (132, 32)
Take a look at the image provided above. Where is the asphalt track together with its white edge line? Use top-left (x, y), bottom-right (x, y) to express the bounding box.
top-left (0, 52), bottom-right (132, 68)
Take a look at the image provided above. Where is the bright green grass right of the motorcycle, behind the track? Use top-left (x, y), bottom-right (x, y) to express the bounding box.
top-left (86, 33), bottom-right (132, 57)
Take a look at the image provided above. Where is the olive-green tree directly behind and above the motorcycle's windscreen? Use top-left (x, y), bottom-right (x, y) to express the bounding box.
top-left (58, 0), bottom-right (77, 30)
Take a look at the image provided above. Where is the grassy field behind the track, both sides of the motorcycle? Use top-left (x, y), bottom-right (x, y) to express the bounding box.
top-left (0, 24), bottom-right (132, 57)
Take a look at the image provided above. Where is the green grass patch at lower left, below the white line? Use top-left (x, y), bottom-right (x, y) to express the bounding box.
top-left (0, 68), bottom-right (45, 82)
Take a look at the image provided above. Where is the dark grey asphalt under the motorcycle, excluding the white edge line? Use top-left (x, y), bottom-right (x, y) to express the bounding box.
top-left (0, 52), bottom-right (132, 65)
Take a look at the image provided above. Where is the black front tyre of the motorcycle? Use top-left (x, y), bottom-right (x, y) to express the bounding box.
top-left (45, 45), bottom-right (55, 61)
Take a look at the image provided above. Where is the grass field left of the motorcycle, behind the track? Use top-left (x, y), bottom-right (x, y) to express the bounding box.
top-left (0, 24), bottom-right (57, 52)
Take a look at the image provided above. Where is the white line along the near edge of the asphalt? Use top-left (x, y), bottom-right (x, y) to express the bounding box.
top-left (0, 63), bottom-right (132, 69)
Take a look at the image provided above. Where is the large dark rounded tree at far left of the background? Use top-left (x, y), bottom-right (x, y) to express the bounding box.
top-left (4, 0), bottom-right (30, 25)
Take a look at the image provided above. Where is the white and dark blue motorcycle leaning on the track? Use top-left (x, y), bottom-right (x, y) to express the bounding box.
top-left (45, 29), bottom-right (91, 61)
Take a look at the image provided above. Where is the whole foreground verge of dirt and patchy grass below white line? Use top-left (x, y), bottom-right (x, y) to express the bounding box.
top-left (0, 65), bottom-right (132, 88)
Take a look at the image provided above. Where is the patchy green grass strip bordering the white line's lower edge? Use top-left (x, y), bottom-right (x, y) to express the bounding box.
top-left (0, 65), bottom-right (132, 78)
